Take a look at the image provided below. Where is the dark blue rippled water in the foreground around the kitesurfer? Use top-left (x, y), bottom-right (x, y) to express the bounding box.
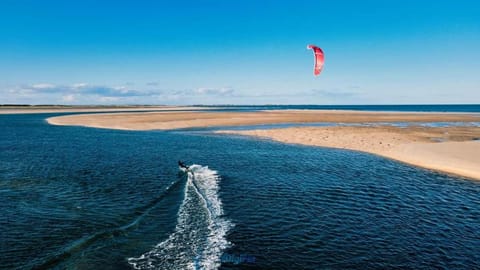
top-left (0, 114), bottom-right (480, 269)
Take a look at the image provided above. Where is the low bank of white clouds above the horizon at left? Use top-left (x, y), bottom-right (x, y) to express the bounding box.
top-left (3, 83), bottom-right (244, 104)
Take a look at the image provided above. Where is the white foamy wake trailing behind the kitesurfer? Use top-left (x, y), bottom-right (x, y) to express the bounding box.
top-left (127, 165), bottom-right (233, 269)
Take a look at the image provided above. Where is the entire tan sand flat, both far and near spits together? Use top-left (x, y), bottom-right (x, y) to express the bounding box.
top-left (47, 110), bottom-right (480, 179)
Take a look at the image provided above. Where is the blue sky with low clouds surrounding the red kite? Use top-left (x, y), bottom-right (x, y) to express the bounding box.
top-left (0, 0), bottom-right (480, 105)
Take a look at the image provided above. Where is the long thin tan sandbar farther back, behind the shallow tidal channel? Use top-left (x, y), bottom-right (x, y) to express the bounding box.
top-left (47, 110), bottom-right (480, 130)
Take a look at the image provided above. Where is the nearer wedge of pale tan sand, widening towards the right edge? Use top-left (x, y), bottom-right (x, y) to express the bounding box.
top-left (216, 126), bottom-right (480, 180)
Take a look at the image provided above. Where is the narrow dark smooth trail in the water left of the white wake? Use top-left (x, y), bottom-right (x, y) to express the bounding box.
top-left (32, 179), bottom-right (182, 269)
